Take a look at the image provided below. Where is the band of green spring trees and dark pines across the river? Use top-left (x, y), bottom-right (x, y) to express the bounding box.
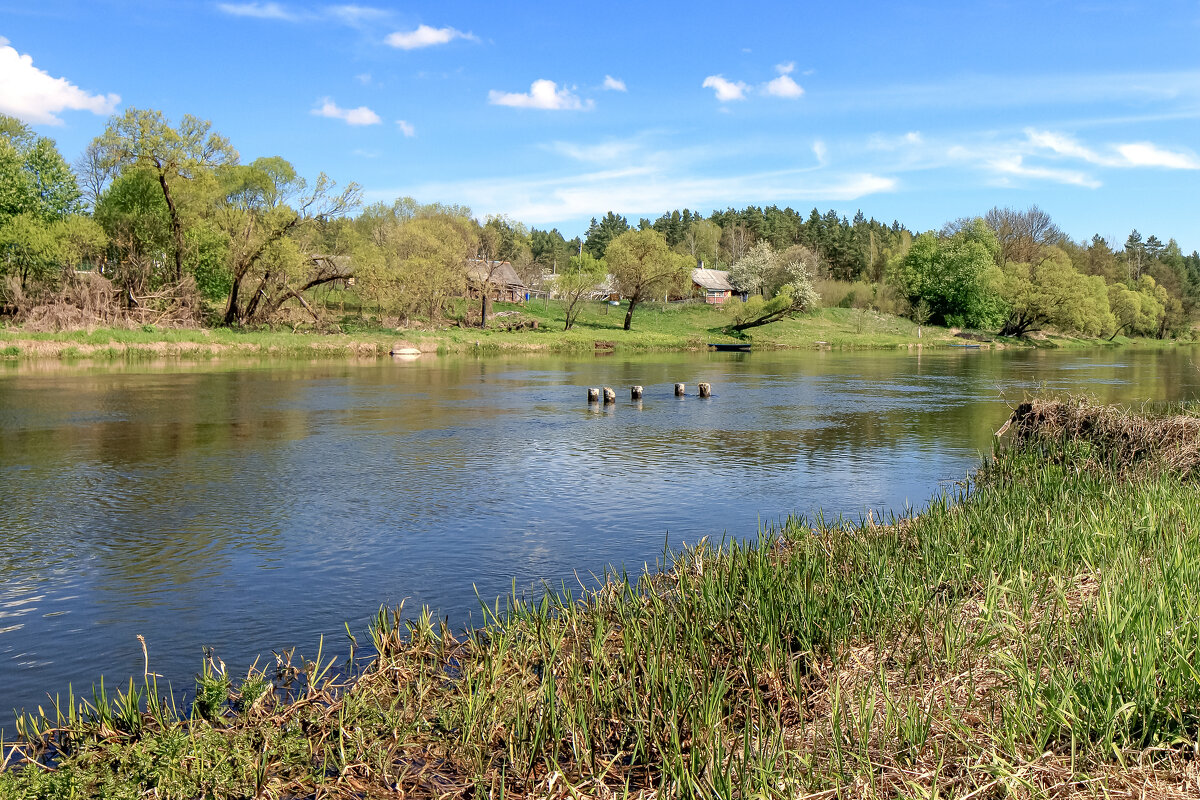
top-left (0, 108), bottom-right (1200, 338)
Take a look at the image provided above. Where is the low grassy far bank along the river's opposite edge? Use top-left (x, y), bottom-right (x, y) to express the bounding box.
top-left (0, 300), bottom-right (1168, 361)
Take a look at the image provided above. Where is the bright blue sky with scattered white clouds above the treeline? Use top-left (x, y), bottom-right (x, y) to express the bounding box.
top-left (0, 0), bottom-right (1200, 252)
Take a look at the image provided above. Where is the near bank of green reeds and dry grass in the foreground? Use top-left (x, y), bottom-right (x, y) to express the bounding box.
top-left (0, 403), bottom-right (1200, 800)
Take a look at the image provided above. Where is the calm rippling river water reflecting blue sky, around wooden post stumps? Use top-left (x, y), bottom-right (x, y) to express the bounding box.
top-left (0, 349), bottom-right (1200, 730)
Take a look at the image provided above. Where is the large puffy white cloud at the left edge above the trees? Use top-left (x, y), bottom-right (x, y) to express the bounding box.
top-left (0, 40), bottom-right (121, 125)
